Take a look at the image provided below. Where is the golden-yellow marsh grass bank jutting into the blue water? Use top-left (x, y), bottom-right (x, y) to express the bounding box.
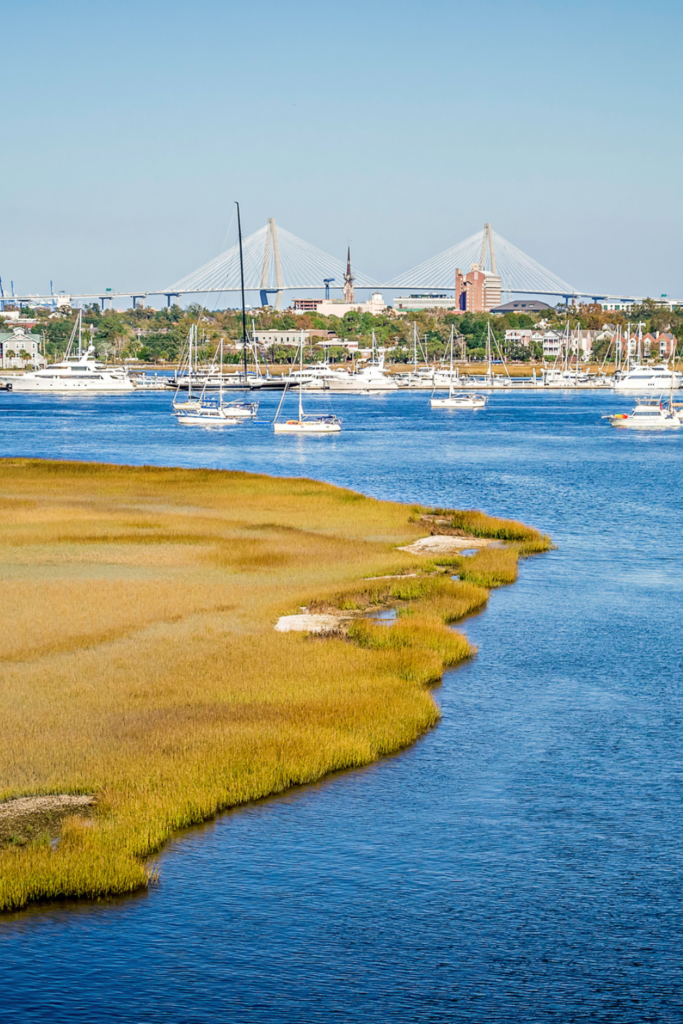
top-left (0, 459), bottom-right (550, 910)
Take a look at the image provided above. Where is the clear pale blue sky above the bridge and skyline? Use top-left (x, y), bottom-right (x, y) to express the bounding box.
top-left (5, 0), bottom-right (683, 298)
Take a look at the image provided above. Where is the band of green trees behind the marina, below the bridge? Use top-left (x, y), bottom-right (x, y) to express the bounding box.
top-left (0, 300), bottom-right (683, 365)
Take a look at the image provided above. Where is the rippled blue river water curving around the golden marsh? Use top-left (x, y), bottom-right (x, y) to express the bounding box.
top-left (0, 392), bottom-right (683, 1024)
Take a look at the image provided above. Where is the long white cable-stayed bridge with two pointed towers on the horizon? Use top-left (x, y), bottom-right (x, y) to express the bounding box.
top-left (0, 218), bottom-right (663, 308)
